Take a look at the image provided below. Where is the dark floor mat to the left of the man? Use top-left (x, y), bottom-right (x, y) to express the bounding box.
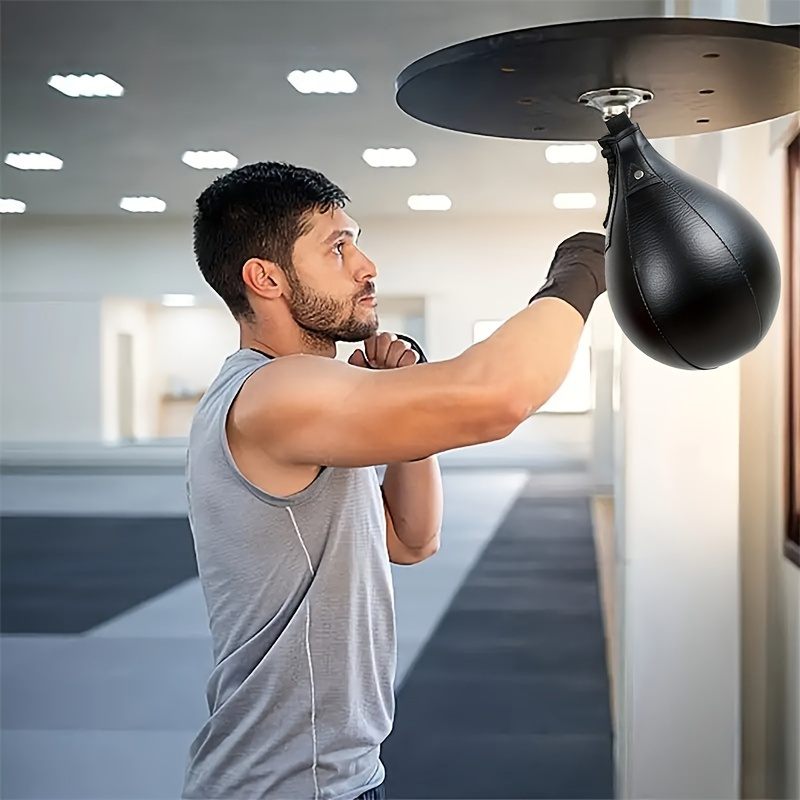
top-left (0, 516), bottom-right (197, 634)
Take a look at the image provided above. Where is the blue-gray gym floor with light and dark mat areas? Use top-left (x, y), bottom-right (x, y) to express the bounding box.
top-left (0, 464), bottom-right (614, 800)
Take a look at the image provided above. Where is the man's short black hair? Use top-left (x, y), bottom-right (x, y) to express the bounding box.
top-left (193, 161), bottom-right (349, 319)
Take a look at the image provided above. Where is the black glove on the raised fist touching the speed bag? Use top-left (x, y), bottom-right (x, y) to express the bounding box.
top-left (529, 231), bottom-right (606, 322)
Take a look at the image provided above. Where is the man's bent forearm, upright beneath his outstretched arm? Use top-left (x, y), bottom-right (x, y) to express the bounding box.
top-left (383, 456), bottom-right (443, 550)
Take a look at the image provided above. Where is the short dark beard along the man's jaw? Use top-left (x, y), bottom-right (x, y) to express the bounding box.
top-left (289, 276), bottom-right (378, 344)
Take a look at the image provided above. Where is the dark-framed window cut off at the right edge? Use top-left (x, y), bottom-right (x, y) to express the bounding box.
top-left (784, 135), bottom-right (800, 566)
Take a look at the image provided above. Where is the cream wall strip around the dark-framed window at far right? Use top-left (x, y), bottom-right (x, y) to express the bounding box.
top-left (736, 117), bottom-right (800, 798)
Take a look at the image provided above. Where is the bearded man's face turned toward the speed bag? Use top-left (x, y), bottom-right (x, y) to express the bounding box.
top-left (287, 209), bottom-right (378, 342)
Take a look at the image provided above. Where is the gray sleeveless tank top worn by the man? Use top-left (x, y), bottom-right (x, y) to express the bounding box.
top-left (183, 350), bottom-right (396, 800)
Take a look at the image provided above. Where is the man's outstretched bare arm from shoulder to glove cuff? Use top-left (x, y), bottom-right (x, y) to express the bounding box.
top-left (230, 297), bottom-right (584, 467)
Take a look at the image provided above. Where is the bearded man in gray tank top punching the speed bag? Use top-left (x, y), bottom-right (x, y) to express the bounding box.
top-left (183, 163), bottom-right (605, 800)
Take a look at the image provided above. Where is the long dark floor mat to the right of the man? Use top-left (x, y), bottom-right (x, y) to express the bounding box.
top-left (382, 492), bottom-right (614, 800)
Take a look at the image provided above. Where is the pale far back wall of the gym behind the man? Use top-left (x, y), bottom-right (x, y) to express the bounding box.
top-left (0, 209), bottom-right (604, 458)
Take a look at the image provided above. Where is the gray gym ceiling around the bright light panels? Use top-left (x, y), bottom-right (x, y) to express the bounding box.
top-left (0, 0), bottom-right (663, 217)
